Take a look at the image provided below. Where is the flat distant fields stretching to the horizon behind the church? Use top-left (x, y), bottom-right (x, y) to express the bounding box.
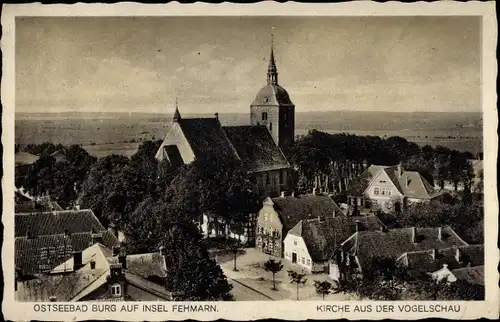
top-left (15, 112), bottom-right (482, 157)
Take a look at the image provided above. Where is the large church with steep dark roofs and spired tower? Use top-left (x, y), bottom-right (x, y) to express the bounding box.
top-left (156, 45), bottom-right (295, 197)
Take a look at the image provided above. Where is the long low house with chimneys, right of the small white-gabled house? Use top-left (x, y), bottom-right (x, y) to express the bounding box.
top-left (329, 226), bottom-right (468, 280)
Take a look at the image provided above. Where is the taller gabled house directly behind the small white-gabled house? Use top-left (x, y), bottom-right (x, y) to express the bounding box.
top-left (255, 194), bottom-right (345, 257)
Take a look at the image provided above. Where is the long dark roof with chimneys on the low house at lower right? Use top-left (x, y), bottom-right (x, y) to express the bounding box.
top-left (342, 226), bottom-right (467, 268)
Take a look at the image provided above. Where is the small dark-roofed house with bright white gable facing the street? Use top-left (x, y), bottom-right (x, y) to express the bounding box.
top-left (284, 215), bottom-right (385, 273)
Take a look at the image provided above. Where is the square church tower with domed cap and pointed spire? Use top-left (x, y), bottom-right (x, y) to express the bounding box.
top-left (250, 37), bottom-right (295, 155)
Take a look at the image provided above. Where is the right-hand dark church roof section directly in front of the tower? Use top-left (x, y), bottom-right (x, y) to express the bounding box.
top-left (223, 125), bottom-right (290, 172)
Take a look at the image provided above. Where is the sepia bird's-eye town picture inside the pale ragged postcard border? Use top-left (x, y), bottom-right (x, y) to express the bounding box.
top-left (2, 1), bottom-right (498, 319)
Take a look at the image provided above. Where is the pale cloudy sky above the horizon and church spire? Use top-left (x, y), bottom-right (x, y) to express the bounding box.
top-left (15, 16), bottom-right (482, 113)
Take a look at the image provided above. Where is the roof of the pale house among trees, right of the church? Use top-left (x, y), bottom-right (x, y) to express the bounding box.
top-left (347, 165), bottom-right (441, 199)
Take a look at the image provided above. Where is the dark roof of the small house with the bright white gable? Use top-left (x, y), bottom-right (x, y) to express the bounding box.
top-left (288, 215), bottom-right (385, 261)
